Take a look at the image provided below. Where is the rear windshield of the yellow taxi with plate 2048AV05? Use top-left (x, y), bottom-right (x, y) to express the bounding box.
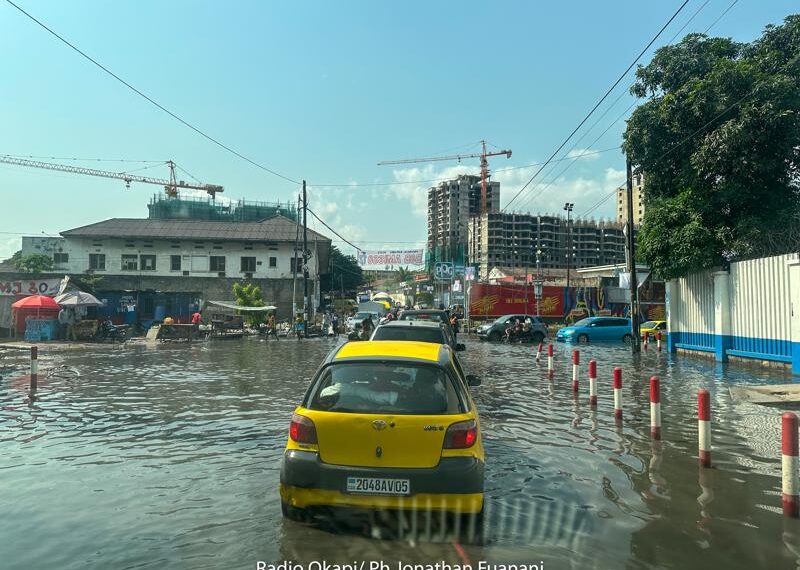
top-left (307, 362), bottom-right (466, 415)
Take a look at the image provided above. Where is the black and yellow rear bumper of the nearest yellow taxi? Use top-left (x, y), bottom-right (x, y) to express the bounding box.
top-left (281, 450), bottom-right (484, 513)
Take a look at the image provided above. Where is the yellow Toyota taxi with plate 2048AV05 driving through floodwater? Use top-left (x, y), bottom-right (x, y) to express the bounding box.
top-left (280, 341), bottom-right (484, 519)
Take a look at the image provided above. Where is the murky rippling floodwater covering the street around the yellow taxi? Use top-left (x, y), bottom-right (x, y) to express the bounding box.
top-left (0, 335), bottom-right (800, 570)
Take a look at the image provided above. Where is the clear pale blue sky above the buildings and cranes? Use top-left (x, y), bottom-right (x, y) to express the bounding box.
top-left (0, 0), bottom-right (798, 258)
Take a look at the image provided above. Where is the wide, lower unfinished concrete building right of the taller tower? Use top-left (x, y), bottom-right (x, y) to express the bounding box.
top-left (469, 213), bottom-right (625, 279)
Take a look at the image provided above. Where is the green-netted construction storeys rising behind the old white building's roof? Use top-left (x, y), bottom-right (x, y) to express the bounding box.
top-left (147, 194), bottom-right (298, 222)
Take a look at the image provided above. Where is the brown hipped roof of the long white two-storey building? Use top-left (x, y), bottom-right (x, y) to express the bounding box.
top-left (61, 214), bottom-right (330, 242)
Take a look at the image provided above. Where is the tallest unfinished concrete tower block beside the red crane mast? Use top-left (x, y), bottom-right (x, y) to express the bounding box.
top-left (428, 175), bottom-right (500, 264)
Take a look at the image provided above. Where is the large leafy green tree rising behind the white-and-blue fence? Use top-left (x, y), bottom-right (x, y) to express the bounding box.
top-left (623, 15), bottom-right (800, 278)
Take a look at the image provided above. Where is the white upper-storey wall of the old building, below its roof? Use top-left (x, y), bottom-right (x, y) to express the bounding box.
top-left (31, 238), bottom-right (318, 279)
